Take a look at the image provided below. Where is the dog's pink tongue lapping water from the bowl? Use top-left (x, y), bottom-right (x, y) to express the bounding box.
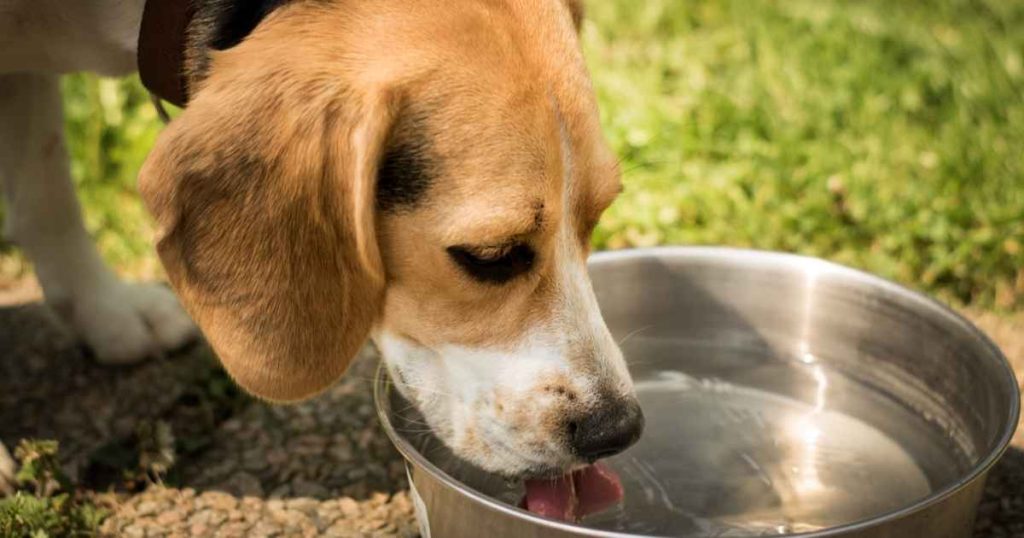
top-left (520, 463), bottom-right (623, 522)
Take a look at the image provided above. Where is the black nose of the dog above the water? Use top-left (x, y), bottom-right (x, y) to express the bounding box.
top-left (568, 398), bottom-right (644, 461)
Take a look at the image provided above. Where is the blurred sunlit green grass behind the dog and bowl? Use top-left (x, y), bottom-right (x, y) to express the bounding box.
top-left (2, 0), bottom-right (1024, 308)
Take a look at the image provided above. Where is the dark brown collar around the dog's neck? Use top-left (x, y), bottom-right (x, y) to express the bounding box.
top-left (138, 0), bottom-right (196, 107)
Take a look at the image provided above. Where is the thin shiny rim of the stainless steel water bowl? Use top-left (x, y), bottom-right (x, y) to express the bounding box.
top-left (374, 246), bottom-right (1021, 538)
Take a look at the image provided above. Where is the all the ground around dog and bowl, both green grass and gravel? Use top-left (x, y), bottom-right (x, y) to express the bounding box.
top-left (0, 0), bottom-right (1024, 537)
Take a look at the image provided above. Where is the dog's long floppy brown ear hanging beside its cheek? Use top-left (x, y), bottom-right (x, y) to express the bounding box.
top-left (139, 42), bottom-right (394, 401)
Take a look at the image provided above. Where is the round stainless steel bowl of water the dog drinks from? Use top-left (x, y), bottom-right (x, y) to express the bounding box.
top-left (376, 244), bottom-right (1019, 538)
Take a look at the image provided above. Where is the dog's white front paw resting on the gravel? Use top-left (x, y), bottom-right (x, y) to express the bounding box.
top-left (65, 282), bottom-right (199, 364)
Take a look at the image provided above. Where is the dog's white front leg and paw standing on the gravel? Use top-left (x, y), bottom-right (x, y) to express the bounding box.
top-left (0, 74), bottom-right (197, 364)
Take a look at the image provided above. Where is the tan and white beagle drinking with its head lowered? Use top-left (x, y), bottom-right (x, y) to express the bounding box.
top-left (0, 0), bottom-right (643, 489)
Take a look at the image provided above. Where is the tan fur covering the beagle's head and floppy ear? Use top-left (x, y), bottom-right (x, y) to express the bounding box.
top-left (140, 0), bottom-right (620, 401)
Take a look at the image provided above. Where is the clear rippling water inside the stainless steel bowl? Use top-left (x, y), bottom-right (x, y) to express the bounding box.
top-left (393, 336), bottom-right (972, 537)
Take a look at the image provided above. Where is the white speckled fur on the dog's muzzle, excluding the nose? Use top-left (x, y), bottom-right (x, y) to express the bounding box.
top-left (374, 236), bottom-right (634, 477)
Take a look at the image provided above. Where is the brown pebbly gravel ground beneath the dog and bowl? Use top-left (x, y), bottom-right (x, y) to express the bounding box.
top-left (0, 286), bottom-right (1024, 538)
